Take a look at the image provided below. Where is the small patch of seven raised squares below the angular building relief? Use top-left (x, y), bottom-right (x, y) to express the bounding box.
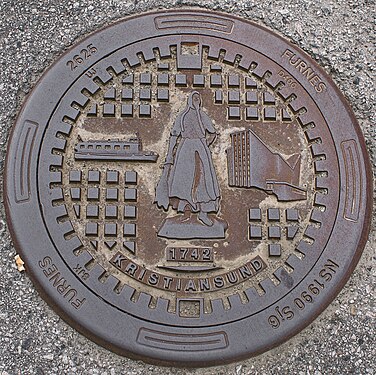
top-left (248, 208), bottom-right (299, 257)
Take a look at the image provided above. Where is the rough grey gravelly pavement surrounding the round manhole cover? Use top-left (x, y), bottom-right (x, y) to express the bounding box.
top-left (0, 0), bottom-right (376, 375)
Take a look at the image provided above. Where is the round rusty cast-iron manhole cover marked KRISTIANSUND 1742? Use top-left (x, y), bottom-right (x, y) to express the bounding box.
top-left (6, 10), bottom-right (371, 366)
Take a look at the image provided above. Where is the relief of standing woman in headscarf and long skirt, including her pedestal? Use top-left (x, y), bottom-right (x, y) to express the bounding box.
top-left (155, 91), bottom-right (227, 239)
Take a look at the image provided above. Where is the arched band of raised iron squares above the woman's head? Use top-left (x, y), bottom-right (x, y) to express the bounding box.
top-left (84, 63), bottom-right (291, 122)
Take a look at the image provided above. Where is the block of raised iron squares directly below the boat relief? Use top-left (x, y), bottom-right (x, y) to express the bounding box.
top-left (69, 170), bottom-right (137, 252)
